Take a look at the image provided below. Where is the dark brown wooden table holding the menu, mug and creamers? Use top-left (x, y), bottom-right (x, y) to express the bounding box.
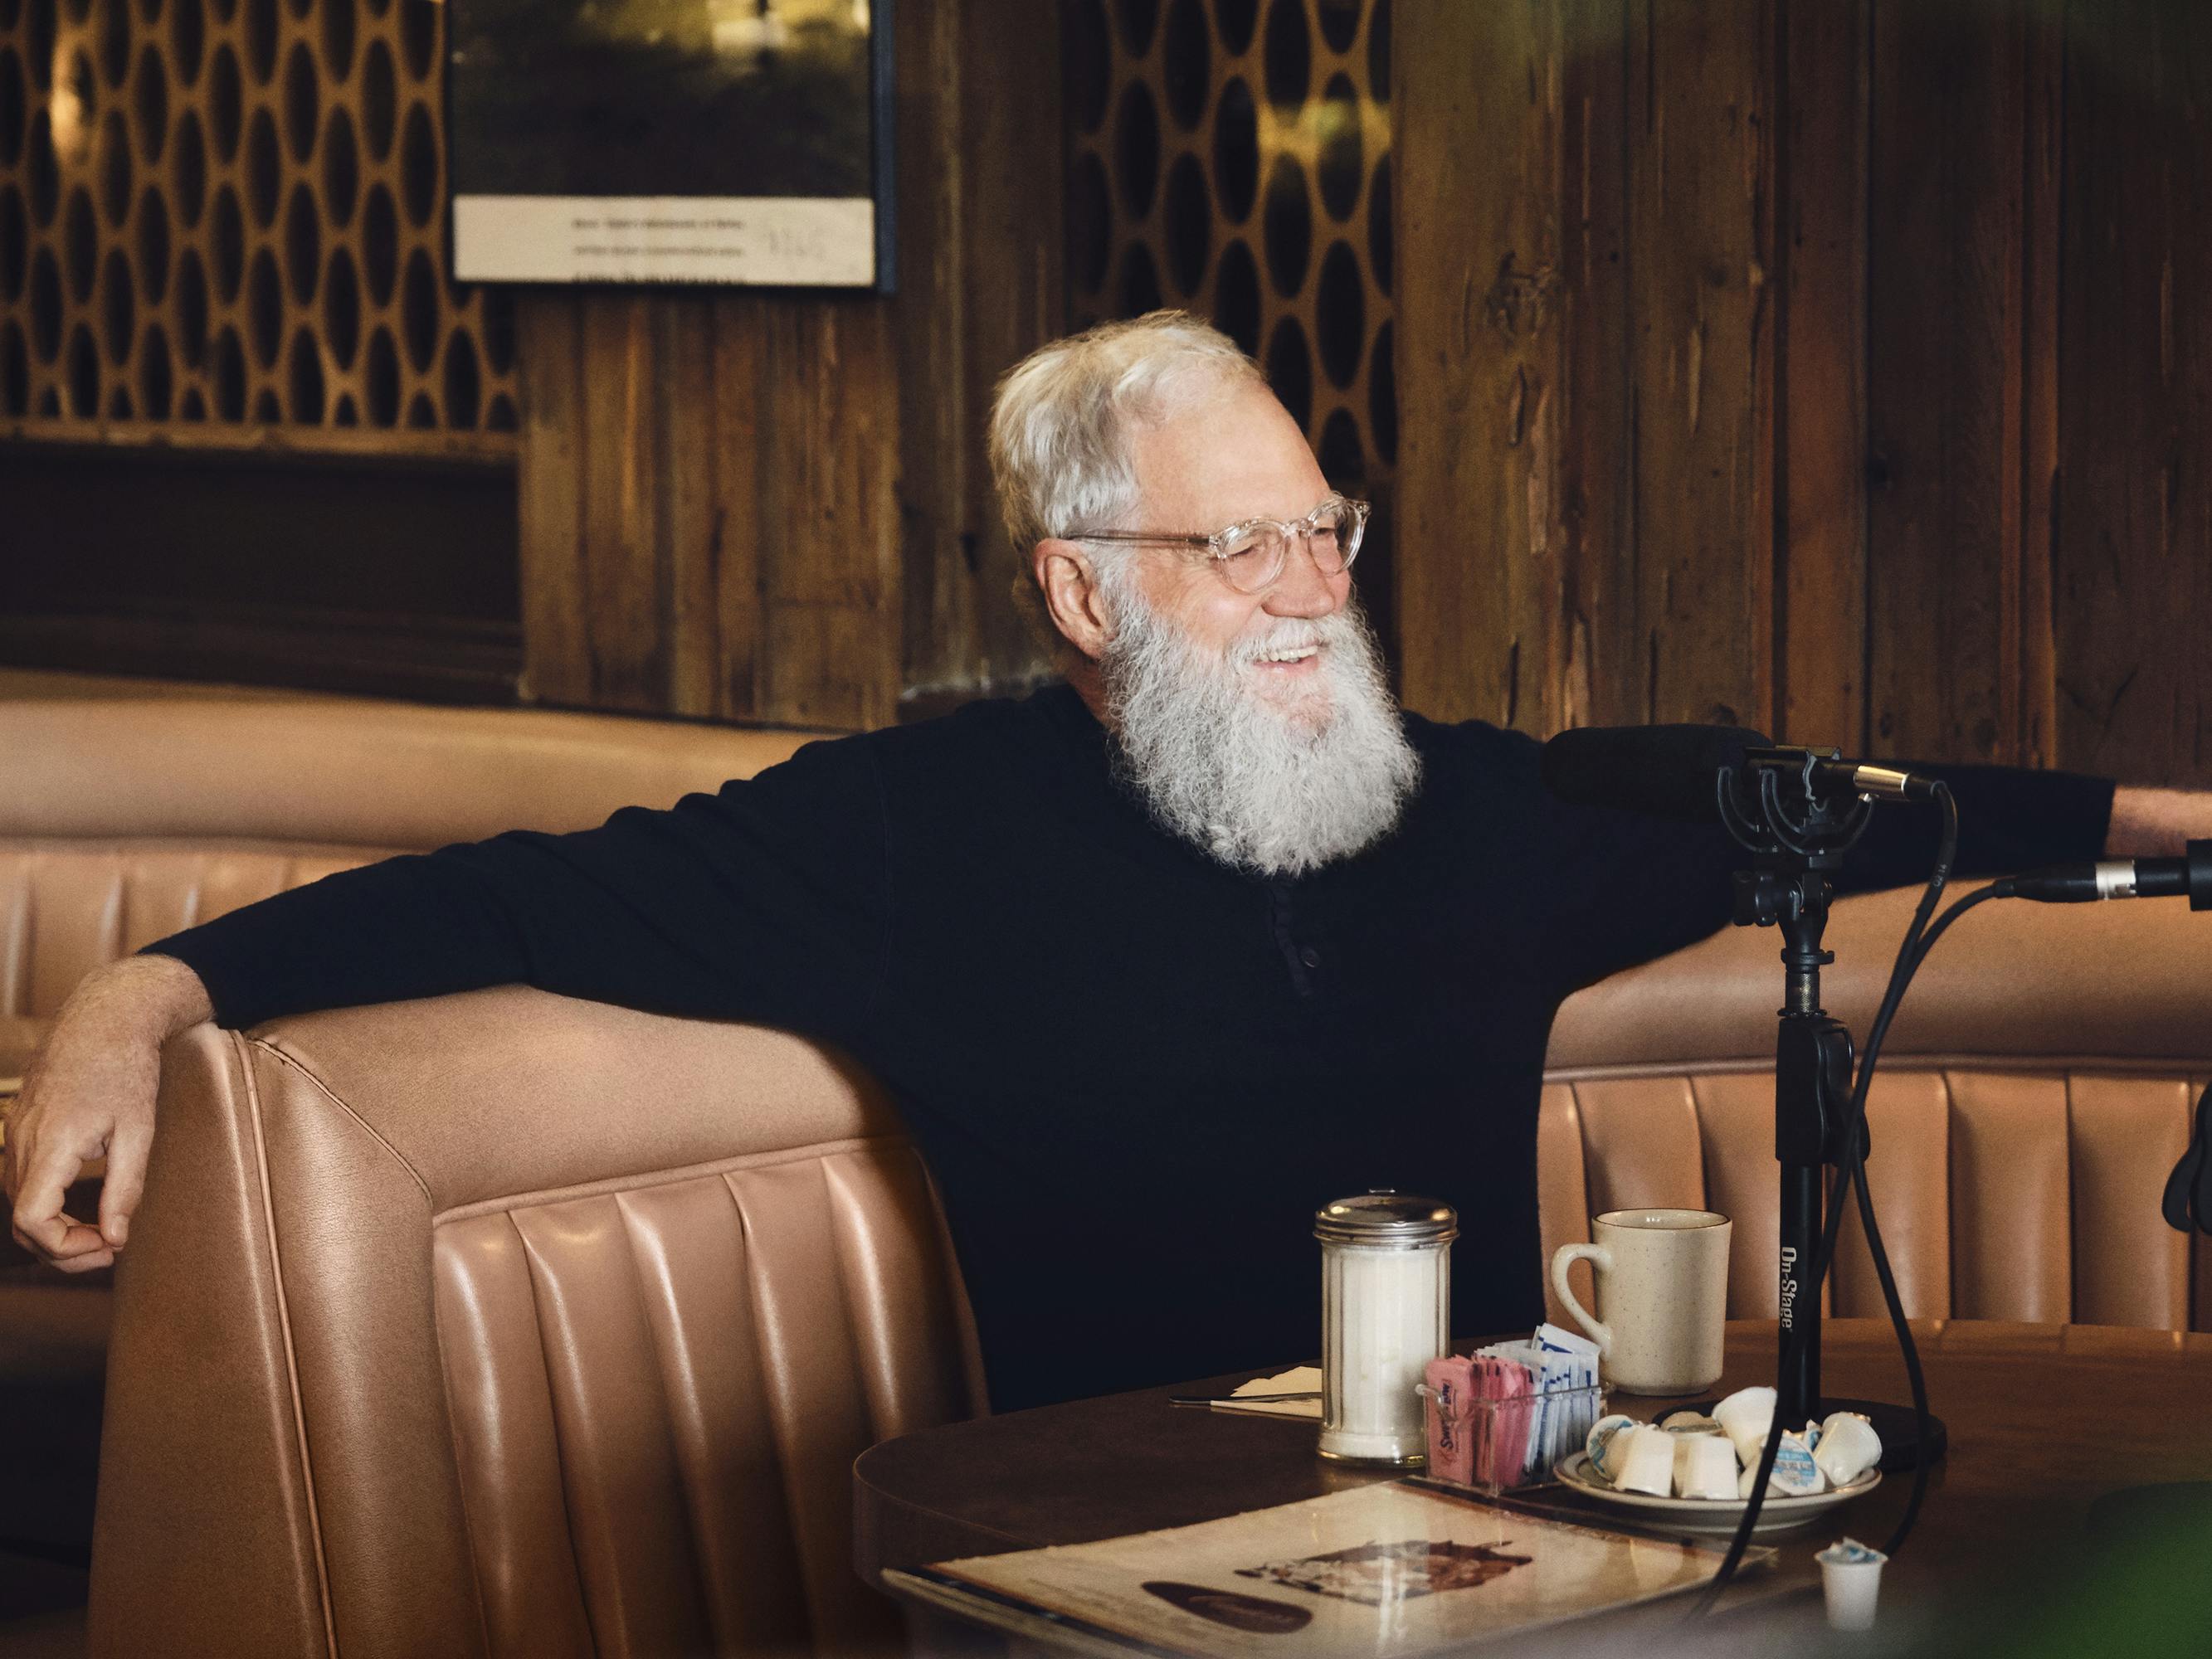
top-left (854, 1321), bottom-right (2212, 1646)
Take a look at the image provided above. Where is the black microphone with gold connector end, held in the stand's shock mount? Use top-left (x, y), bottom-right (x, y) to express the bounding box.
top-left (1542, 726), bottom-right (1936, 820)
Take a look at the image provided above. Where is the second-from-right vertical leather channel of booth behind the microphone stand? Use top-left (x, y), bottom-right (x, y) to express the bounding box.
top-left (1944, 1071), bottom-right (2073, 1323)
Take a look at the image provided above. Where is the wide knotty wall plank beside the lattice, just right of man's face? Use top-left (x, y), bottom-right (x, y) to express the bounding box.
top-left (1394, 0), bottom-right (1562, 730)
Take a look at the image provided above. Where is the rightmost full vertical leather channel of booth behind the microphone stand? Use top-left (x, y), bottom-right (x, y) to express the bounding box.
top-left (2066, 1073), bottom-right (2196, 1331)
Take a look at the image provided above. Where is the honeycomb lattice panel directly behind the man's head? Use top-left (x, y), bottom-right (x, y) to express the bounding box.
top-left (1066, 0), bottom-right (1398, 494)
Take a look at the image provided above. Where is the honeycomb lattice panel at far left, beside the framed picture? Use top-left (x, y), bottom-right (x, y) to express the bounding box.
top-left (0, 0), bottom-right (515, 447)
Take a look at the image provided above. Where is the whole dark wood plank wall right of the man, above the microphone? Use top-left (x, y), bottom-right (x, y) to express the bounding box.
top-left (1396, 0), bottom-right (2212, 783)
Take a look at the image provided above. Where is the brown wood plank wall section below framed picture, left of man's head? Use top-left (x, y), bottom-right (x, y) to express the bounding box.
top-left (520, 0), bottom-right (1062, 727)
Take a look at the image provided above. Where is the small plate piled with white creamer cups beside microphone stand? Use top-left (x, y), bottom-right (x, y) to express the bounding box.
top-left (1553, 1389), bottom-right (1883, 1537)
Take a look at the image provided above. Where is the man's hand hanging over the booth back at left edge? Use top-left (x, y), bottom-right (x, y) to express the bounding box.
top-left (0, 956), bottom-right (215, 1274)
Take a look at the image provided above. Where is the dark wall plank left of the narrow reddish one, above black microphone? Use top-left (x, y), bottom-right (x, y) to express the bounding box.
top-left (1628, 0), bottom-right (1774, 726)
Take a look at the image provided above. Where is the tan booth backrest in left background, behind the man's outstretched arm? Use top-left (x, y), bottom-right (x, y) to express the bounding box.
top-left (0, 697), bottom-right (807, 1075)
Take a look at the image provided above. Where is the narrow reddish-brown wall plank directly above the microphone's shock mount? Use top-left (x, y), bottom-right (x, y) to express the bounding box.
top-left (1776, 0), bottom-right (1873, 754)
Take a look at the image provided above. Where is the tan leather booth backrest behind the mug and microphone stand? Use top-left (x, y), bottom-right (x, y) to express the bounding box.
top-left (1540, 892), bottom-right (2212, 1330)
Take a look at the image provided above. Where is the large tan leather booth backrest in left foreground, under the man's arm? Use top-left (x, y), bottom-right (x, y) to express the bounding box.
top-left (90, 989), bottom-right (982, 1659)
